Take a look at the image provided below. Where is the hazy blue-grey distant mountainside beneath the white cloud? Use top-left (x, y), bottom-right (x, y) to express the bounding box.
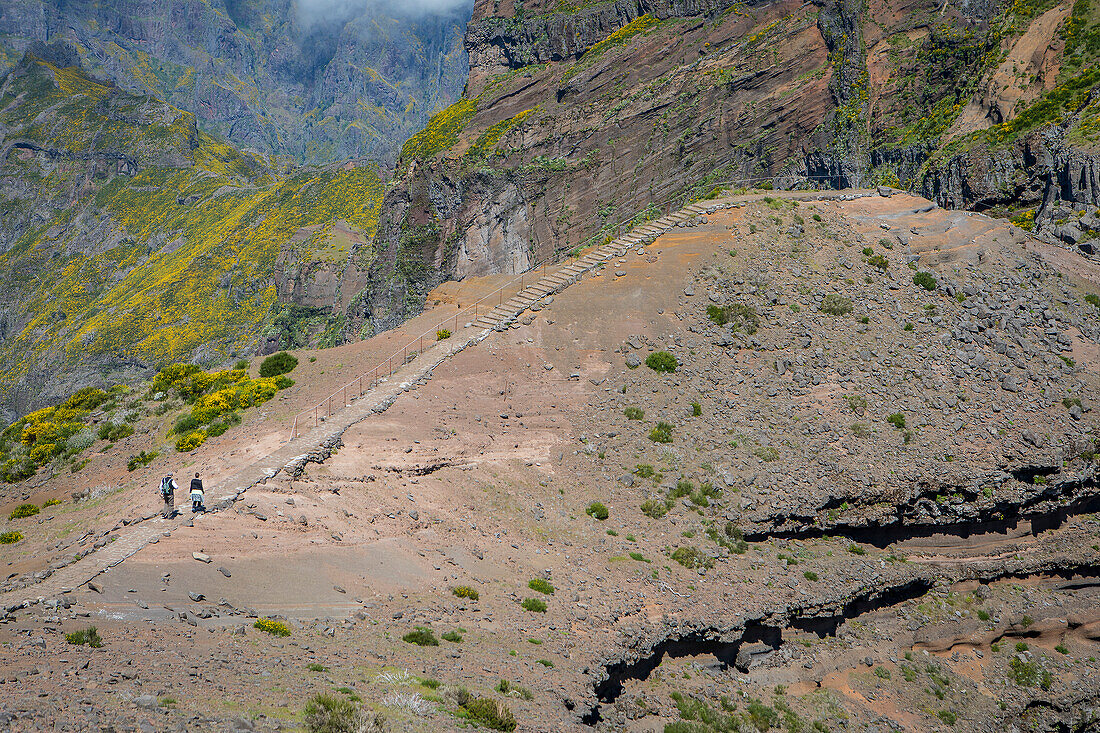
top-left (0, 0), bottom-right (470, 162)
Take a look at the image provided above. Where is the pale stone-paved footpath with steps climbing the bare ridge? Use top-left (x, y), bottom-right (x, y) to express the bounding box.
top-left (0, 189), bottom-right (880, 610)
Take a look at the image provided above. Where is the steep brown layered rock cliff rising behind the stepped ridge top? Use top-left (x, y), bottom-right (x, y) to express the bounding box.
top-left (349, 0), bottom-right (1100, 336)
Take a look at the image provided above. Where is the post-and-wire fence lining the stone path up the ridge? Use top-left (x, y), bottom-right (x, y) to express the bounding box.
top-left (290, 175), bottom-right (847, 433)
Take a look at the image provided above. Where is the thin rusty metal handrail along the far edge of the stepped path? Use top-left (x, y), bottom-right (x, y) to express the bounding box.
top-left (290, 176), bottom-right (840, 433)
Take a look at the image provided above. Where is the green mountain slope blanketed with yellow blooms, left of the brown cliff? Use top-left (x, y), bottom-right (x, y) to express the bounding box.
top-left (0, 47), bottom-right (382, 415)
